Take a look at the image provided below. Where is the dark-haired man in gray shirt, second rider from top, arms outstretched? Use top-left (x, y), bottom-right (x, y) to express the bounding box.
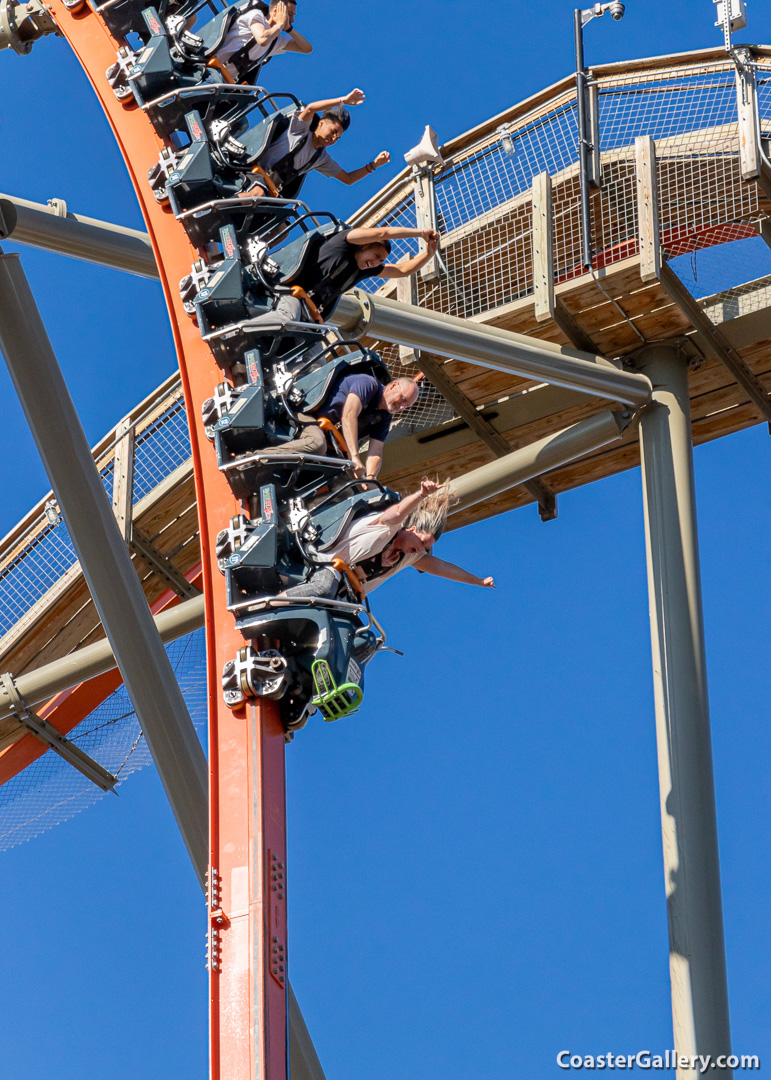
top-left (251, 90), bottom-right (391, 199)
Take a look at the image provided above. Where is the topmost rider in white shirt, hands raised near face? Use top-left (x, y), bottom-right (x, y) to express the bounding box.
top-left (211, 0), bottom-right (313, 82)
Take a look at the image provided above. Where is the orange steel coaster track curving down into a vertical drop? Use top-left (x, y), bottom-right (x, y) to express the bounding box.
top-left (51, 0), bottom-right (287, 1080)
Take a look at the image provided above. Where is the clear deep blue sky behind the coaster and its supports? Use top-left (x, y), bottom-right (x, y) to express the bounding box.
top-left (0, 0), bottom-right (771, 1080)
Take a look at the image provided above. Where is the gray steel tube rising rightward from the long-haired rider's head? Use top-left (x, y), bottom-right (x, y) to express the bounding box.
top-left (451, 409), bottom-right (632, 514)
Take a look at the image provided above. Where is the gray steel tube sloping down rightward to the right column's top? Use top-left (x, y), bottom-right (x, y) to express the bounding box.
top-left (330, 289), bottom-right (651, 408)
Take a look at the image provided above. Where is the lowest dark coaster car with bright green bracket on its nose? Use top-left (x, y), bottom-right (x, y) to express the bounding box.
top-left (217, 480), bottom-right (398, 730)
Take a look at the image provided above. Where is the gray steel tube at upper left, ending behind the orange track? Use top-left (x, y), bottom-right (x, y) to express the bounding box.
top-left (0, 194), bottom-right (159, 279)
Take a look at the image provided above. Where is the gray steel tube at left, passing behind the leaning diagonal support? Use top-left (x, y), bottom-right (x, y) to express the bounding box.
top-left (0, 596), bottom-right (204, 720)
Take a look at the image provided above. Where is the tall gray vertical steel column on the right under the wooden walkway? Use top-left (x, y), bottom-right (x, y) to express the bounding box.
top-left (636, 345), bottom-right (733, 1080)
